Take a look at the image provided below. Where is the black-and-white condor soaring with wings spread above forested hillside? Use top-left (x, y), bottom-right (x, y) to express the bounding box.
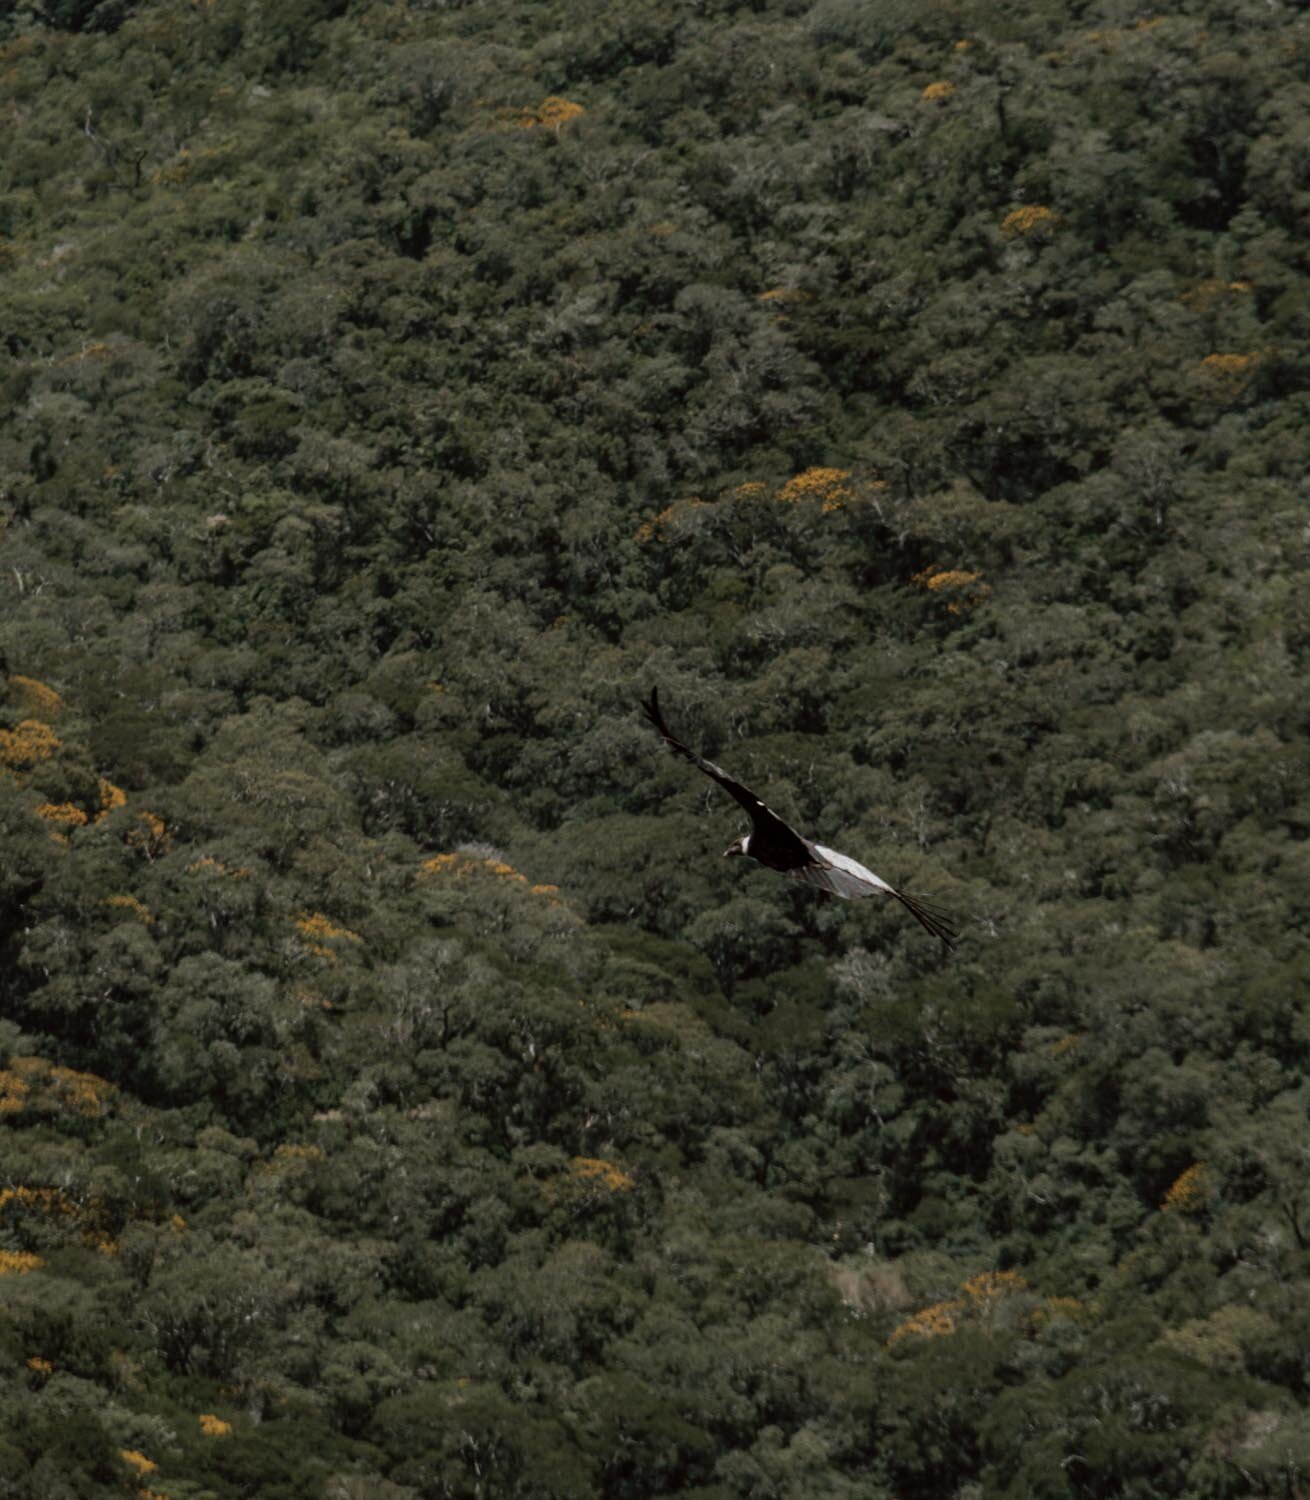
top-left (642, 687), bottom-right (956, 950)
